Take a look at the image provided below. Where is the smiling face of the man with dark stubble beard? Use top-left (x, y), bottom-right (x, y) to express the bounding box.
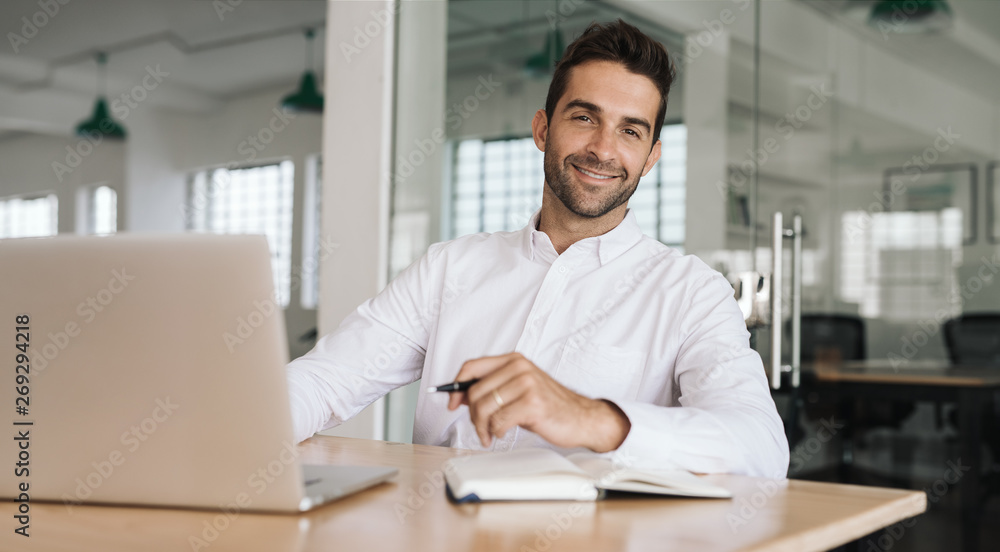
top-left (532, 61), bottom-right (660, 218)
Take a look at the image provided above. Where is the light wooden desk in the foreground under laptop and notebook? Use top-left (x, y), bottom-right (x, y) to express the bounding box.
top-left (0, 437), bottom-right (927, 552)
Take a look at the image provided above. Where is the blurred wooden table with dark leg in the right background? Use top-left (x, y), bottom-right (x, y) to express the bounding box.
top-left (803, 360), bottom-right (1000, 551)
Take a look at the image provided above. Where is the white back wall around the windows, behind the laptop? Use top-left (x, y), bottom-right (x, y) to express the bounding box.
top-left (0, 82), bottom-right (321, 357)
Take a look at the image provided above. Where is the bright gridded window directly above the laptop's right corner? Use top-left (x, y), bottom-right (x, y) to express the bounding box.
top-left (188, 161), bottom-right (294, 306)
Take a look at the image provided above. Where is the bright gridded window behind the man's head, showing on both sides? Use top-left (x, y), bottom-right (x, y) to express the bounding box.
top-left (451, 124), bottom-right (687, 248)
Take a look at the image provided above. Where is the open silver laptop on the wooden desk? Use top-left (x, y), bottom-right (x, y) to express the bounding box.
top-left (0, 234), bottom-right (397, 512)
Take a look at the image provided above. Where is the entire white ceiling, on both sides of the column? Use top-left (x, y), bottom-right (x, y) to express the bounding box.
top-left (0, 0), bottom-right (1000, 142)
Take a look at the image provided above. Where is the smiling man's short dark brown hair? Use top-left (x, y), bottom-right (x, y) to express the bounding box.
top-left (545, 19), bottom-right (676, 144)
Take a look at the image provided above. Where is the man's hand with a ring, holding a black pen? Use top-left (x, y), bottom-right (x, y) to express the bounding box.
top-left (448, 353), bottom-right (632, 452)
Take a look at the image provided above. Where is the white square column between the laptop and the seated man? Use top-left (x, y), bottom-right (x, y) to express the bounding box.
top-left (319, 0), bottom-right (396, 439)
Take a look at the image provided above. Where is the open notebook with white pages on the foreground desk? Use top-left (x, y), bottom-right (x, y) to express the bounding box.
top-left (444, 449), bottom-right (732, 502)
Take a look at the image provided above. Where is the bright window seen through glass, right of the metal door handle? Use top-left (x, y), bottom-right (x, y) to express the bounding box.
top-left (840, 208), bottom-right (963, 321)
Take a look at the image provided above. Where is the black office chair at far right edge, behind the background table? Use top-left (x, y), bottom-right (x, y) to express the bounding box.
top-left (944, 312), bottom-right (1000, 500)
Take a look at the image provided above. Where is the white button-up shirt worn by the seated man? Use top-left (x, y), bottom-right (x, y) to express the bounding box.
top-left (287, 212), bottom-right (788, 478)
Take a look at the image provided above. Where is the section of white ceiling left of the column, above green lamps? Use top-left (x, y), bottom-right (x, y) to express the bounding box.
top-left (0, 0), bottom-right (327, 137)
